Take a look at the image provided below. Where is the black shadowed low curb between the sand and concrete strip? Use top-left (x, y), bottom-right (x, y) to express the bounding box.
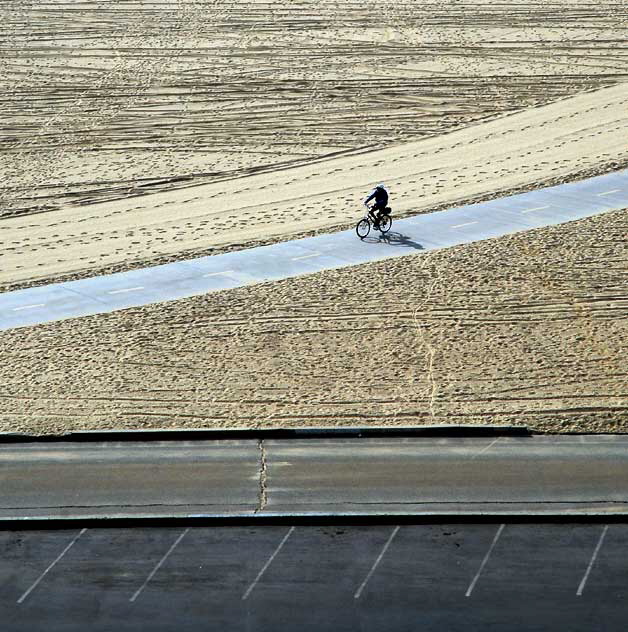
top-left (0, 425), bottom-right (532, 444)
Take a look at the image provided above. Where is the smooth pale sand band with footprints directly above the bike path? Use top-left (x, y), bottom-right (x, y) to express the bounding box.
top-left (0, 84), bottom-right (628, 292)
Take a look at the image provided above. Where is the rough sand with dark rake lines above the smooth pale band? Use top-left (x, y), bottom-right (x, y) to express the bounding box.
top-left (0, 0), bottom-right (628, 216)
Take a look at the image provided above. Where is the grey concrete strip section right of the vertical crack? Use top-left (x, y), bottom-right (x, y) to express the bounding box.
top-left (265, 435), bottom-right (628, 514)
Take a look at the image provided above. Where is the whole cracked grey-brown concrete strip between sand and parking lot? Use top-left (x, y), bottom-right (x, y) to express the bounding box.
top-left (0, 435), bottom-right (628, 520)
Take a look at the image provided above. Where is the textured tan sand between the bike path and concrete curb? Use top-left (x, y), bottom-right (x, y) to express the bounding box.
top-left (0, 210), bottom-right (628, 433)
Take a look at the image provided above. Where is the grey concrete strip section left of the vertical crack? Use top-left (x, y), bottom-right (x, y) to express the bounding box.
top-left (0, 440), bottom-right (259, 519)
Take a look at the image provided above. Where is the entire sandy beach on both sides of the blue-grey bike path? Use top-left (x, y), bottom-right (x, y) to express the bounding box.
top-left (0, 1), bottom-right (628, 433)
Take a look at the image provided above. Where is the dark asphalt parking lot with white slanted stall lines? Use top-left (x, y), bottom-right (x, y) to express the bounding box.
top-left (0, 523), bottom-right (628, 632)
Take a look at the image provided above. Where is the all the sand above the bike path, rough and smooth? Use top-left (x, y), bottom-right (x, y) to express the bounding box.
top-left (0, 0), bottom-right (628, 290)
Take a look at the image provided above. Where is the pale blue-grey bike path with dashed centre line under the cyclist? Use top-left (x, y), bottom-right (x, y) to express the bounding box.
top-left (0, 170), bottom-right (628, 330)
